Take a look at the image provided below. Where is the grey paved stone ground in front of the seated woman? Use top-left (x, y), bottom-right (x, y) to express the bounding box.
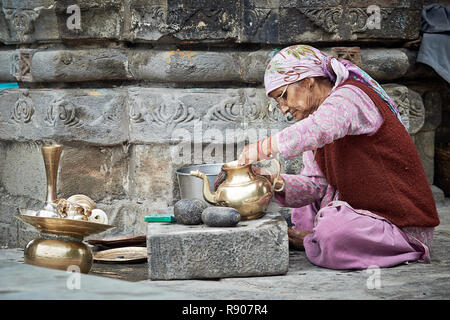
top-left (0, 198), bottom-right (450, 300)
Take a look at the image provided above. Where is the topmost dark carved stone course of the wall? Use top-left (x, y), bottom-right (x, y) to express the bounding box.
top-left (0, 0), bottom-right (421, 44)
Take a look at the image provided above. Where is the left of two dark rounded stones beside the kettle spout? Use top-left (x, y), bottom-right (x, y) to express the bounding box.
top-left (173, 199), bottom-right (208, 225)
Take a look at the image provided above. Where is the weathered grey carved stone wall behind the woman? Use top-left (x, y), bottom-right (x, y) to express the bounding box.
top-left (0, 0), bottom-right (448, 246)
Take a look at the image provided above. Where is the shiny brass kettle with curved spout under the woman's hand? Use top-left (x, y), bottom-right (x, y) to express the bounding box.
top-left (190, 159), bottom-right (282, 220)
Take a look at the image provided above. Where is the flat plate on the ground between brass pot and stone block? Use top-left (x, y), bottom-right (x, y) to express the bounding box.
top-left (94, 247), bottom-right (147, 263)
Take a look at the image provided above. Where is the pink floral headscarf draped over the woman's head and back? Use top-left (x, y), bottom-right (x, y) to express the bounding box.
top-left (264, 45), bottom-right (403, 123)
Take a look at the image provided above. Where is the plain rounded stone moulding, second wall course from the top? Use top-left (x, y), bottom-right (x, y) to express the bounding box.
top-left (0, 47), bottom-right (428, 84)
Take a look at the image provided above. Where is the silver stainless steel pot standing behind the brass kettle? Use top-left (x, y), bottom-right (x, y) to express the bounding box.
top-left (176, 163), bottom-right (224, 199)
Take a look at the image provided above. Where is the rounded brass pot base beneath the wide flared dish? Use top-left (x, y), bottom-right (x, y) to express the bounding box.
top-left (24, 235), bottom-right (93, 273)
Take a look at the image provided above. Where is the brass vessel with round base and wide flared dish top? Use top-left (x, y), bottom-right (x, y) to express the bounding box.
top-left (14, 209), bottom-right (115, 273)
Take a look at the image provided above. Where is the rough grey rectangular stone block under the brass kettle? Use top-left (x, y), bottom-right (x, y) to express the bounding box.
top-left (147, 213), bottom-right (289, 280)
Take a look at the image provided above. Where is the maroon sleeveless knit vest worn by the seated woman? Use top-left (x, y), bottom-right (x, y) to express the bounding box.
top-left (315, 80), bottom-right (439, 227)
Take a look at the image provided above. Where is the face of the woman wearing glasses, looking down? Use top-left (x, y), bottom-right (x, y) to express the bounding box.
top-left (269, 78), bottom-right (331, 120)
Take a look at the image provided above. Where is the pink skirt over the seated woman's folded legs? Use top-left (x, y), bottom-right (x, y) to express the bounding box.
top-left (292, 201), bottom-right (434, 269)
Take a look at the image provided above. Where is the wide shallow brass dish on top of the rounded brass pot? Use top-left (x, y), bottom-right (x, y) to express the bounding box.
top-left (14, 209), bottom-right (115, 238)
